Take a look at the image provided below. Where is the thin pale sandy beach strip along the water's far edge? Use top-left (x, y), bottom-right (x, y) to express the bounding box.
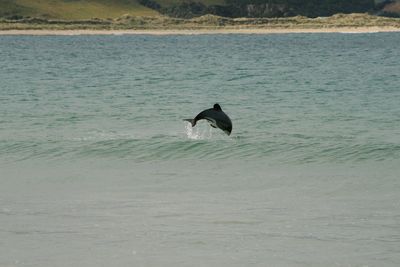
top-left (0, 26), bottom-right (400, 36)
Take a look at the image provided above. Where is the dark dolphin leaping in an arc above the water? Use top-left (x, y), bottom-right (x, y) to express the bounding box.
top-left (184, 104), bottom-right (232, 135)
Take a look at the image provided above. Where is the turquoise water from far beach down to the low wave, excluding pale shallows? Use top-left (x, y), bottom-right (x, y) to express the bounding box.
top-left (0, 33), bottom-right (400, 163)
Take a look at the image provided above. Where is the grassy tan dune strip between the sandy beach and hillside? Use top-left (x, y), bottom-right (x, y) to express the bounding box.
top-left (0, 14), bottom-right (400, 30)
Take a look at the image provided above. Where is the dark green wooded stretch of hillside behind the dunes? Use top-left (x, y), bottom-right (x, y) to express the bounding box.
top-left (155, 0), bottom-right (400, 18)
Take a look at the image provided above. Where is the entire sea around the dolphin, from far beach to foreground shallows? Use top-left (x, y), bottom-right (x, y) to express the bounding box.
top-left (0, 33), bottom-right (400, 266)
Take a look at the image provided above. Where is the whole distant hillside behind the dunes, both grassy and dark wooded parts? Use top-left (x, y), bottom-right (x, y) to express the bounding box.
top-left (0, 0), bottom-right (400, 20)
